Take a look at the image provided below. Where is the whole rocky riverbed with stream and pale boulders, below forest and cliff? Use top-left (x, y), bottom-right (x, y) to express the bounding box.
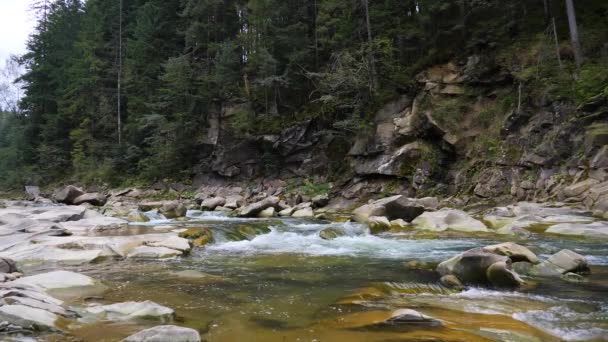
top-left (0, 189), bottom-right (608, 341)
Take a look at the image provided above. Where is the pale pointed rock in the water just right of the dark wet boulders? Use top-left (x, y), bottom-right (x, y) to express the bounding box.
top-left (531, 249), bottom-right (589, 277)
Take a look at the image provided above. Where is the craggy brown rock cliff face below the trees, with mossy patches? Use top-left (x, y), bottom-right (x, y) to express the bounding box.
top-left (195, 56), bottom-right (608, 210)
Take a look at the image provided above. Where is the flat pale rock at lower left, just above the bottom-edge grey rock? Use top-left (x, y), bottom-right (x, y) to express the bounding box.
top-left (86, 300), bottom-right (174, 320)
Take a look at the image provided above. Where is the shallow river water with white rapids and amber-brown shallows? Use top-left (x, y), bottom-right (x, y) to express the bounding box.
top-left (35, 211), bottom-right (608, 341)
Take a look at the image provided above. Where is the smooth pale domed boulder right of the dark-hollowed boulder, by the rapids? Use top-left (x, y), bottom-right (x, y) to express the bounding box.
top-left (412, 209), bottom-right (488, 232)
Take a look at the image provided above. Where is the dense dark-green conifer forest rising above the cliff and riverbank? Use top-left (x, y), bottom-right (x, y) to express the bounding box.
top-left (0, 0), bottom-right (608, 188)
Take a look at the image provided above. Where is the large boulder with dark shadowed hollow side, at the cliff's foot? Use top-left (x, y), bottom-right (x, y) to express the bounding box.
top-left (353, 195), bottom-right (439, 223)
